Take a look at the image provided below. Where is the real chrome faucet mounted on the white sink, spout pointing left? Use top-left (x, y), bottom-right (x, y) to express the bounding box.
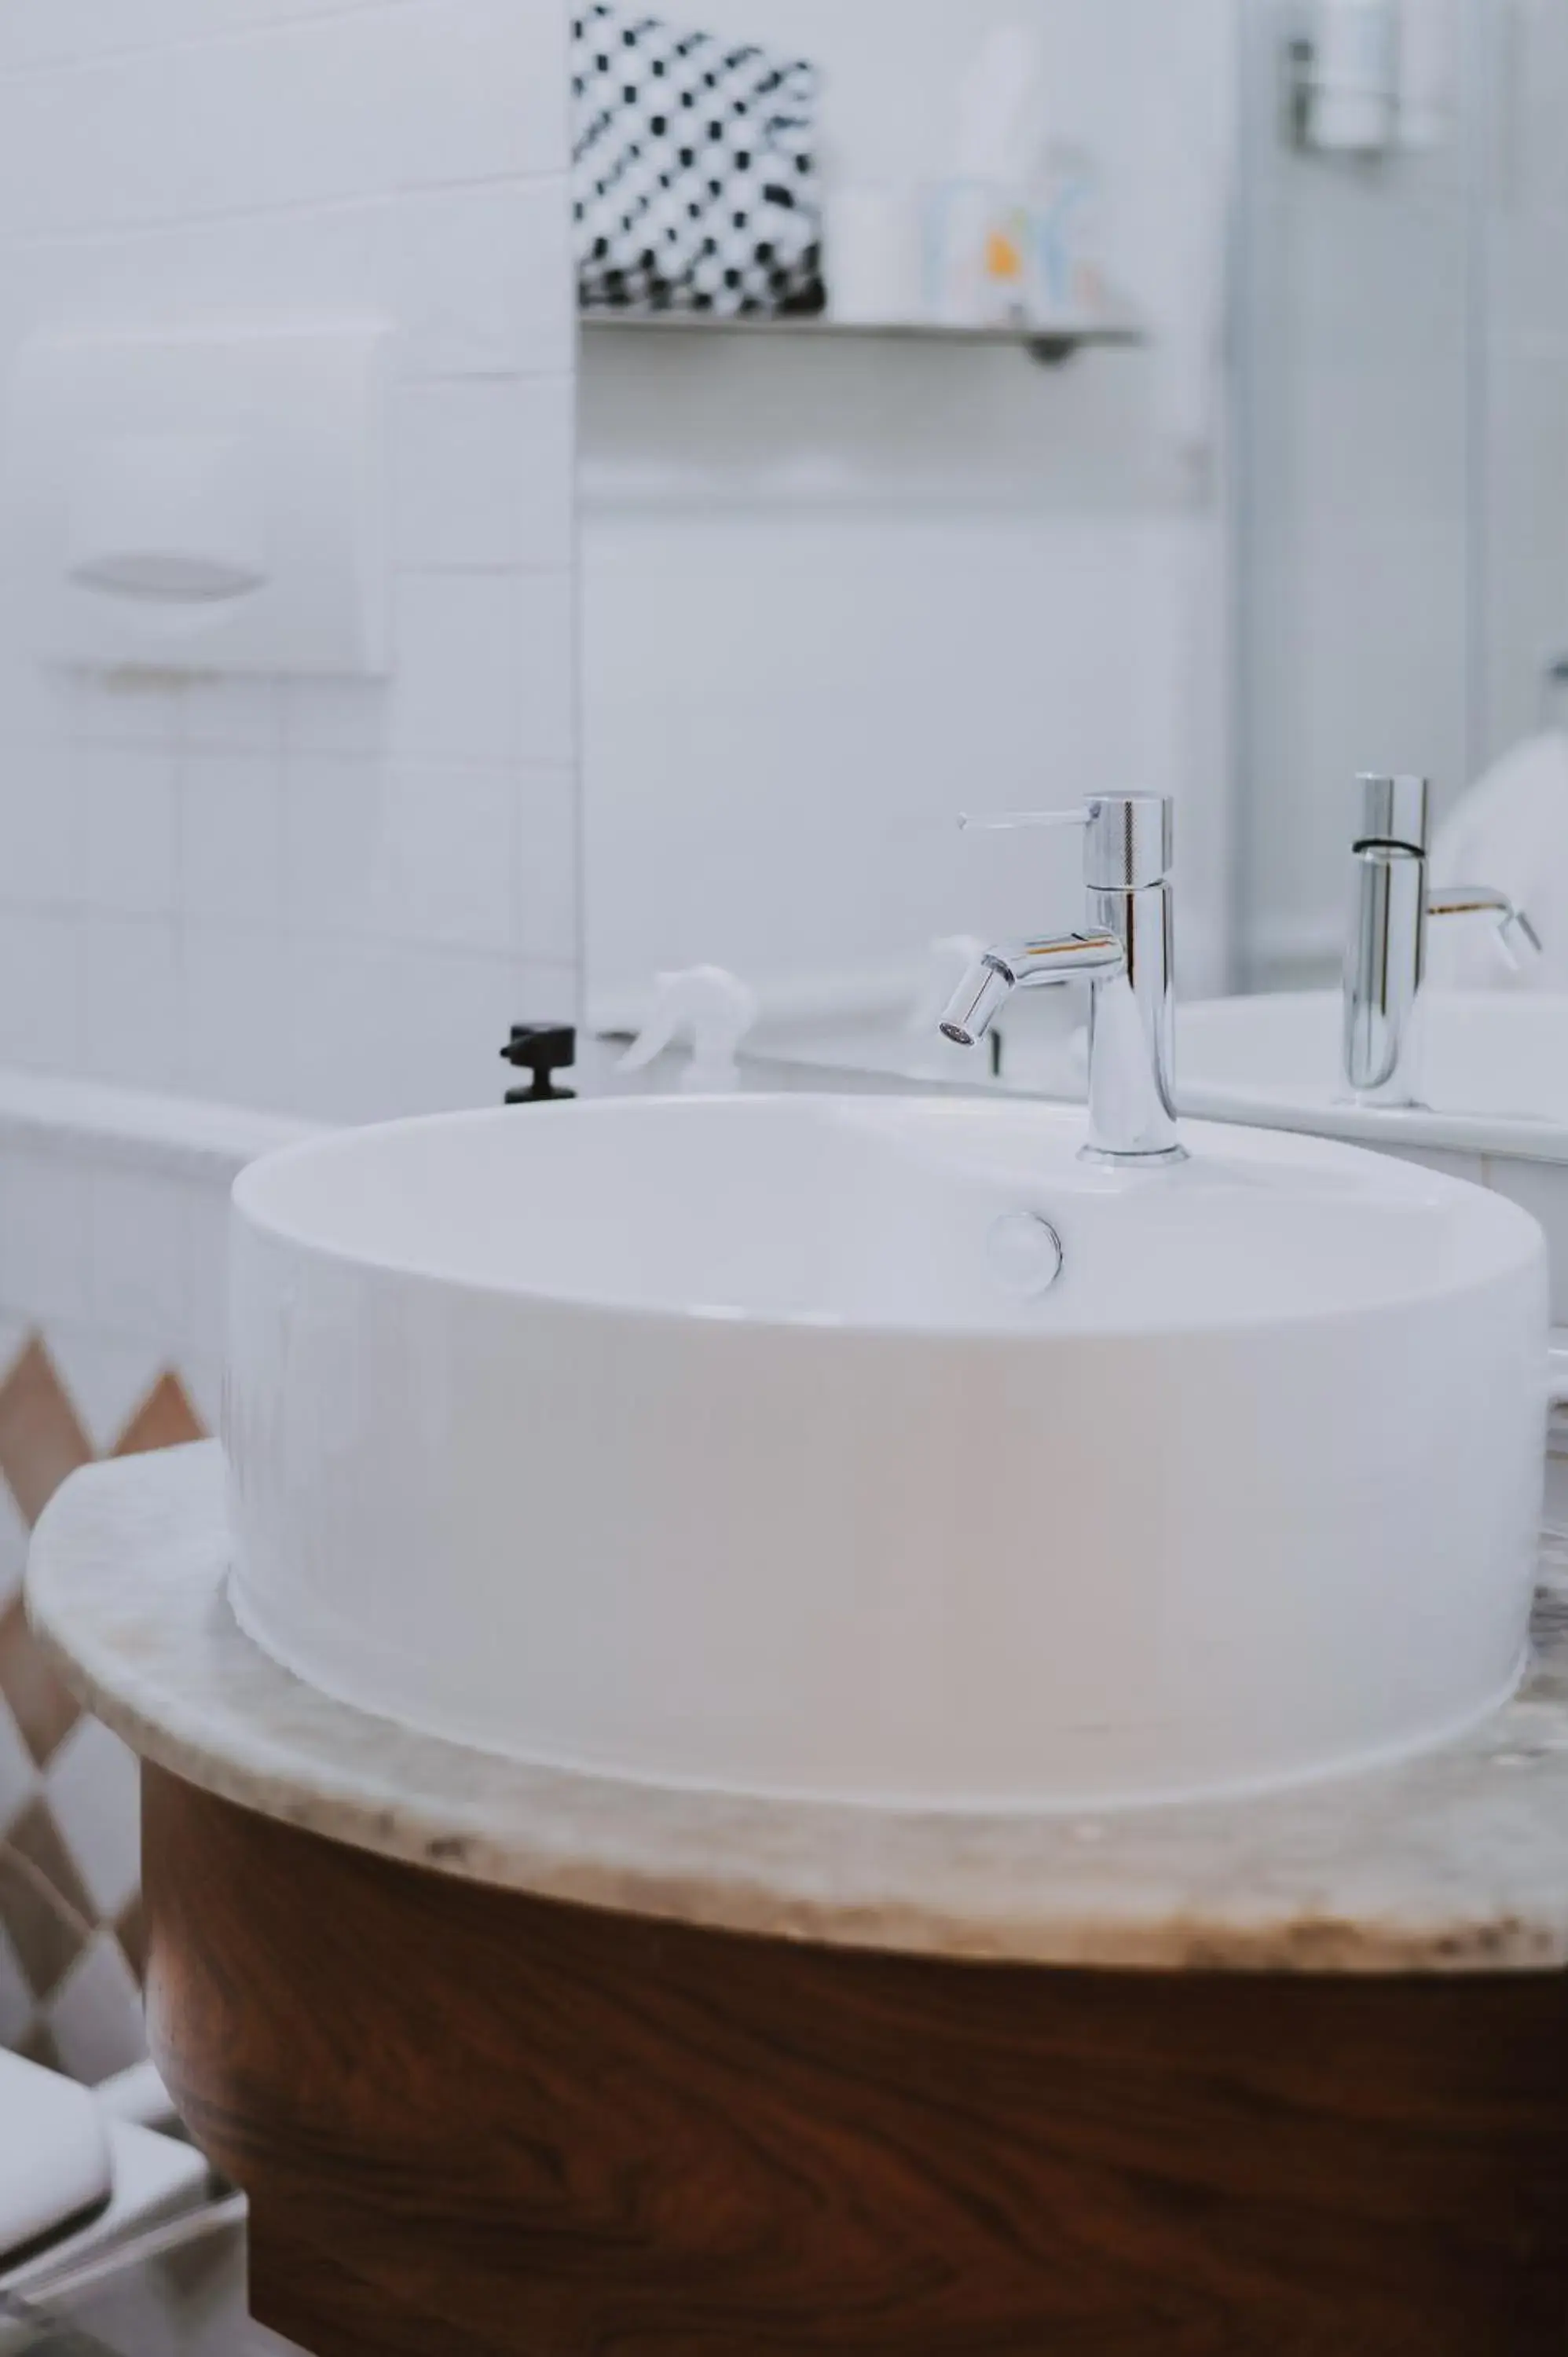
top-left (941, 794), bottom-right (1186, 1169)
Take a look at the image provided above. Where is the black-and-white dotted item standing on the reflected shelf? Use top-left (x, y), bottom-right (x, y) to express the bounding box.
top-left (573, 0), bottom-right (823, 318)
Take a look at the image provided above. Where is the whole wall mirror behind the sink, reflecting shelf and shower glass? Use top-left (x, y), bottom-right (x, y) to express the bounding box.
top-left (575, 0), bottom-right (1568, 1070)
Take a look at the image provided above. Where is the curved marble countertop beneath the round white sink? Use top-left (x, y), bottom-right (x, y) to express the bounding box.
top-left (28, 1445), bottom-right (1568, 1973)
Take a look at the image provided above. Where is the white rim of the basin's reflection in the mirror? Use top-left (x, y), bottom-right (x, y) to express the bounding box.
top-left (1177, 990), bottom-right (1568, 1162)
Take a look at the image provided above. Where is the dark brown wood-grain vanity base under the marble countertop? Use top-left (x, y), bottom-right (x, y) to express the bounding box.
top-left (144, 1770), bottom-right (1568, 2357)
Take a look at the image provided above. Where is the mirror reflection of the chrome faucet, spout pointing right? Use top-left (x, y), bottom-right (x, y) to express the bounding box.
top-left (1344, 775), bottom-right (1540, 1108)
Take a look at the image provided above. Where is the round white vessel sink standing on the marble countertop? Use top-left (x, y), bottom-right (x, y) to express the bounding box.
top-left (226, 1096), bottom-right (1547, 1808)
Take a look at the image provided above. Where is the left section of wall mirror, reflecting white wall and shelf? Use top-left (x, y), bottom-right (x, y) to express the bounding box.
top-left (575, 0), bottom-right (1231, 1070)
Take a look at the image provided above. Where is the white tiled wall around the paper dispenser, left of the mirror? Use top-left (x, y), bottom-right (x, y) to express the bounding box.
top-left (0, 0), bottom-right (577, 1117)
